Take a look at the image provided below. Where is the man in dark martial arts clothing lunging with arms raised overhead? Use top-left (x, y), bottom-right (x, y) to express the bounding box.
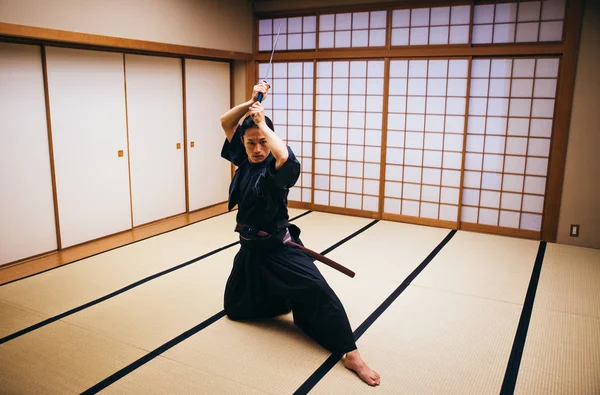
top-left (221, 81), bottom-right (380, 386)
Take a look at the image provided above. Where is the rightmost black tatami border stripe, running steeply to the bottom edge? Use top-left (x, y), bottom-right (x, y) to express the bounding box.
top-left (500, 241), bottom-right (546, 395)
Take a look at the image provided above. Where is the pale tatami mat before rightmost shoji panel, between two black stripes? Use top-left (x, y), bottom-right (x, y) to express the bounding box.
top-left (412, 231), bottom-right (540, 305)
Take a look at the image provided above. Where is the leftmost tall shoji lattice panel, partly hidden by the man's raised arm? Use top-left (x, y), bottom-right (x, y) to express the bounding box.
top-left (259, 62), bottom-right (314, 203)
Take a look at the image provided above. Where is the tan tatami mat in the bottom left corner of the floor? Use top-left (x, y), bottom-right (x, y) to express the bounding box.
top-left (0, 321), bottom-right (146, 395)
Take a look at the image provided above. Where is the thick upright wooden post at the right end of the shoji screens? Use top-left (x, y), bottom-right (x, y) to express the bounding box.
top-left (542, 0), bottom-right (591, 242)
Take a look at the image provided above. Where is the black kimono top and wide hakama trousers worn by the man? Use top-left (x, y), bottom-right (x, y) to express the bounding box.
top-left (221, 127), bottom-right (356, 353)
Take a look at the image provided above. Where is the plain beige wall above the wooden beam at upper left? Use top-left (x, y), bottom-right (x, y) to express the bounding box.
top-left (0, 0), bottom-right (252, 52)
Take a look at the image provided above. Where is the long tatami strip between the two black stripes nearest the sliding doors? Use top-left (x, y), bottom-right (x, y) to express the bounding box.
top-left (0, 209), bottom-right (306, 337)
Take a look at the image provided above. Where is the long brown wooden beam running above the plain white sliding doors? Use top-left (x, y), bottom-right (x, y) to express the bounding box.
top-left (0, 22), bottom-right (252, 60)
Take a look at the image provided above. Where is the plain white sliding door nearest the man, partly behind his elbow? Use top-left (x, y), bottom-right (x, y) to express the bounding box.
top-left (185, 59), bottom-right (231, 211)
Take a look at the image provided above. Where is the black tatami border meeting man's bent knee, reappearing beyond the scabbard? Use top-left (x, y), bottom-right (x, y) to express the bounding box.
top-left (82, 218), bottom-right (379, 395)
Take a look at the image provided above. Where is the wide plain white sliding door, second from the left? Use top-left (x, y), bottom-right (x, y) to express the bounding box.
top-left (46, 47), bottom-right (131, 247)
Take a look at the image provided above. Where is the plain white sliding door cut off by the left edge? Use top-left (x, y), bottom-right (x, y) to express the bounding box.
top-left (0, 43), bottom-right (57, 265)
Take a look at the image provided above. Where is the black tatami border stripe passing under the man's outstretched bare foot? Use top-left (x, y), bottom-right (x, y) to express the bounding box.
top-left (294, 229), bottom-right (456, 395)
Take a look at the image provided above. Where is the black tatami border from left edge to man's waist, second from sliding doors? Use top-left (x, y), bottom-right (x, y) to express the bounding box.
top-left (0, 210), bottom-right (312, 344)
